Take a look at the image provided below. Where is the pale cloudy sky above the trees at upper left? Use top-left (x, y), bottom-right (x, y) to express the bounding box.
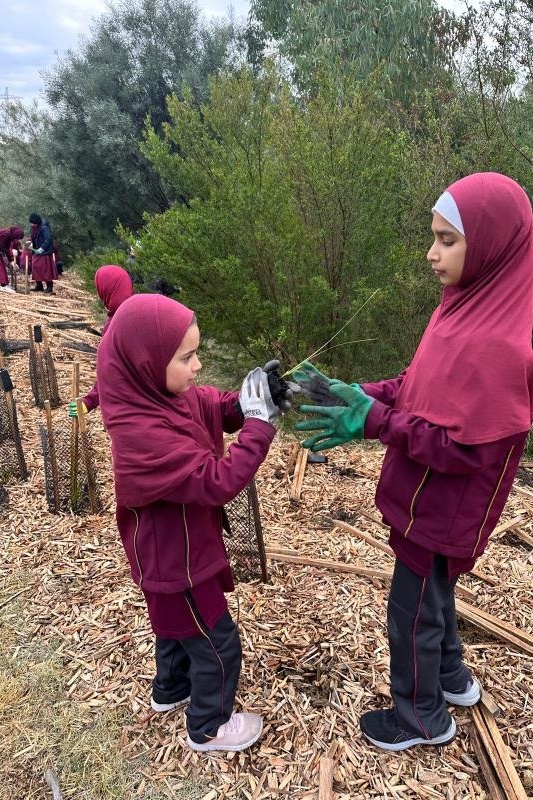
top-left (0, 0), bottom-right (249, 100)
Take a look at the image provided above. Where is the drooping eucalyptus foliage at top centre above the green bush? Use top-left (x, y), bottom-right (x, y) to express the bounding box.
top-left (248, 0), bottom-right (455, 101)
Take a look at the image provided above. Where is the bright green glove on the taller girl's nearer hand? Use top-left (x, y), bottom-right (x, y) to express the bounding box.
top-left (294, 383), bottom-right (374, 453)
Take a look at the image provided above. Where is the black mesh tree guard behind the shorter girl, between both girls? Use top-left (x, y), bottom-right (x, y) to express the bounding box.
top-left (224, 480), bottom-right (268, 582)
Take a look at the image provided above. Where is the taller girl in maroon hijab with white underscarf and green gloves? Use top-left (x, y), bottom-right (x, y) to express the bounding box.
top-left (294, 172), bottom-right (533, 750)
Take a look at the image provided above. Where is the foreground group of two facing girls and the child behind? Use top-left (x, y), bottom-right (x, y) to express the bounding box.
top-left (74, 173), bottom-right (533, 751)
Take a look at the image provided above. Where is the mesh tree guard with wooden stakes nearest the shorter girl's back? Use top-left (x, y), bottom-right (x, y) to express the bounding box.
top-left (40, 362), bottom-right (102, 516)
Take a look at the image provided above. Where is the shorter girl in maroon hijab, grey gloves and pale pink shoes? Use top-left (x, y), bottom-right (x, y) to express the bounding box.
top-left (97, 294), bottom-right (278, 751)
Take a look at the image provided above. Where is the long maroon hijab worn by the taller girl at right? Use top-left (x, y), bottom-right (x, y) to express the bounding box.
top-left (396, 172), bottom-right (533, 444)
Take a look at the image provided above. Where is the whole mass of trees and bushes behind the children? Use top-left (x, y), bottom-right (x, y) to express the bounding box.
top-left (0, 0), bottom-right (533, 380)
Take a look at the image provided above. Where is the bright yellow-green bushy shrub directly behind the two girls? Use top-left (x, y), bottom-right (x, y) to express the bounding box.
top-left (134, 68), bottom-right (448, 377)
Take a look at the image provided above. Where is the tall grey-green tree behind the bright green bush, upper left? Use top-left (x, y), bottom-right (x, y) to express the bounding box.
top-left (44, 0), bottom-right (239, 243)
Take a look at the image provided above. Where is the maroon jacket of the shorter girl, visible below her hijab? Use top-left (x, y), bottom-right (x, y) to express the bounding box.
top-left (117, 392), bottom-right (276, 594)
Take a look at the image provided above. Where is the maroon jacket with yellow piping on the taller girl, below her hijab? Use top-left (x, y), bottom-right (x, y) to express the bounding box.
top-left (361, 374), bottom-right (528, 559)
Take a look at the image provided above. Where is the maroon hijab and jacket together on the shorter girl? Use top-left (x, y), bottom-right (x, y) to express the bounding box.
top-left (97, 294), bottom-right (276, 594)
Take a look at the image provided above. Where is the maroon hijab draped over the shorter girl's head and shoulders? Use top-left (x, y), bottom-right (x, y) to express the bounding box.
top-left (97, 294), bottom-right (223, 506)
